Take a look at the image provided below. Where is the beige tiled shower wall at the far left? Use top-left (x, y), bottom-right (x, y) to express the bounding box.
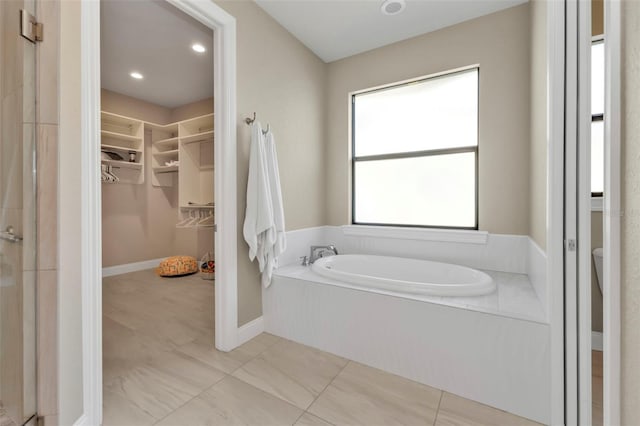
top-left (0, 0), bottom-right (60, 426)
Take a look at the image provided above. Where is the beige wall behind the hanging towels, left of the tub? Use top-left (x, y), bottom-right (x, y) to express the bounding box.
top-left (216, 1), bottom-right (326, 325)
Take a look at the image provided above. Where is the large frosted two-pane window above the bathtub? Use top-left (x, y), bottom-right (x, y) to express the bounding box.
top-left (351, 68), bottom-right (479, 229)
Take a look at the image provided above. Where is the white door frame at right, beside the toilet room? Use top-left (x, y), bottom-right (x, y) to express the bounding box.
top-left (566, 0), bottom-right (623, 425)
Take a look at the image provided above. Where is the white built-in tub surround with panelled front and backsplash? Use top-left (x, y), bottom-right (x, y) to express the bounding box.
top-left (263, 226), bottom-right (550, 423)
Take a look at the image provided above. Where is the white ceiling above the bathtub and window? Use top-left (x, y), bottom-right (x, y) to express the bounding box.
top-left (255, 0), bottom-right (527, 62)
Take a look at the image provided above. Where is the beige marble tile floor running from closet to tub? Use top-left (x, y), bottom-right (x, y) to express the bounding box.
top-left (103, 271), bottom-right (537, 426)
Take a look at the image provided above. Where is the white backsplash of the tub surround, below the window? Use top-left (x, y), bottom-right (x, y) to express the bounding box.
top-left (279, 226), bottom-right (548, 318)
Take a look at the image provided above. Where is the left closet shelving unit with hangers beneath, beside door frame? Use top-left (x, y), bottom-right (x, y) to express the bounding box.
top-left (100, 111), bottom-right (144, 184)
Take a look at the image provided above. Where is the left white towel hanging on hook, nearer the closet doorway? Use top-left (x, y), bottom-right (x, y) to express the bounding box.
top-left (242, 121), bottom-right (276, 272)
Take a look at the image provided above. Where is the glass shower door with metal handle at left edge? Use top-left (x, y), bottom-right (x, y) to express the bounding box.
top-left (0, 0), bottom-right (36, 426)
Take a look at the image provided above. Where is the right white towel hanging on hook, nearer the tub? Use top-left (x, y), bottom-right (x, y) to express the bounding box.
top-left (262, 131), bottom-right (287, 288)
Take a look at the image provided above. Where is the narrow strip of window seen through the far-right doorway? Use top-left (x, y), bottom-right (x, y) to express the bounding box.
top-left (591, 40), bottom-right (604, 197)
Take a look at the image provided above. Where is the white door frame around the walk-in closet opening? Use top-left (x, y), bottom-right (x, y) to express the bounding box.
top-left (75, 0), bottom-right (239, 425)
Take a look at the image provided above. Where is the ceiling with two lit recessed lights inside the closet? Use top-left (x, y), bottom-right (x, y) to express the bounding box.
top-left (100, 0), bottom-right (213, 108)
